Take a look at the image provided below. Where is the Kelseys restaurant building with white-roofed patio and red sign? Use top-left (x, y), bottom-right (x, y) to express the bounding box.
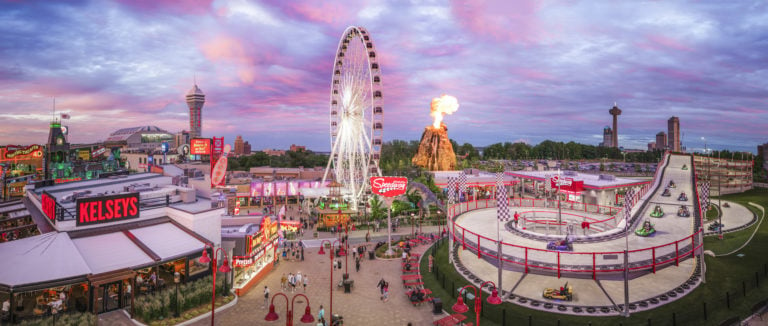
top-left (0, 173), bottom-right (224, 323)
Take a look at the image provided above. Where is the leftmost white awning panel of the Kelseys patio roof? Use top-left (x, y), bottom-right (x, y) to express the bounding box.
top-left (0, 232), bottom-right (91, 287)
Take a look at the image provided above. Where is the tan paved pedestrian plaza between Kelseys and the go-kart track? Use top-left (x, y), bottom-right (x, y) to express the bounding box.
top-left (193, 227), bottom-right (439, 326)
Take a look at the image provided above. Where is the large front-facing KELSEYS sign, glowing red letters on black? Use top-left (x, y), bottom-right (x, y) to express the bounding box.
top-left (76, 193), bottom-right (139, 226)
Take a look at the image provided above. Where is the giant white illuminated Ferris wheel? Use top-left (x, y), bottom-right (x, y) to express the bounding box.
top-left (323, 26), bottom-right (384, 209)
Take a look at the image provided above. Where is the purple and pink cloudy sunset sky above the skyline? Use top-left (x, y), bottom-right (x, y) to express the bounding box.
top-left (0, 0), bottom-right (768, 152)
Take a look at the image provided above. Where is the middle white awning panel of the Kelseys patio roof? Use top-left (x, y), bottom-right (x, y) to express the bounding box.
top-left (72, 232), bottom-right (154, 274)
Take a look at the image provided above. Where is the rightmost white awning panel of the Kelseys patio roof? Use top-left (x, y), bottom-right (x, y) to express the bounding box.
top-left (131, 223), bottom-right (205, 260)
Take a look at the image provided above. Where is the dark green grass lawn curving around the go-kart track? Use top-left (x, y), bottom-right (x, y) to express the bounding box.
top-left (421, 189), bottom-right (768, 326)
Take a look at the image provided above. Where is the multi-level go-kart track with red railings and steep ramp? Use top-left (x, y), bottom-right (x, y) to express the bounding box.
top-left (449, 154), bottom-right (751, 315)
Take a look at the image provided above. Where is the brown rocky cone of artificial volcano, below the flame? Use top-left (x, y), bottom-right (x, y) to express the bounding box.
top-left (411, 123), bottom-right (456, 171)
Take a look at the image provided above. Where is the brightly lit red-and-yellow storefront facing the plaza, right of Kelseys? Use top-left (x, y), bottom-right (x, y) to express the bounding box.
top-left (232, 217), bottom-right (279, 295)
